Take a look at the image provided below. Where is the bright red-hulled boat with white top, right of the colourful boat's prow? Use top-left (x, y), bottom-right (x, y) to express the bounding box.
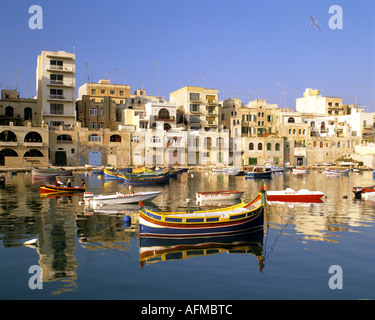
top-left (267, 188), bottom-right (324, 202)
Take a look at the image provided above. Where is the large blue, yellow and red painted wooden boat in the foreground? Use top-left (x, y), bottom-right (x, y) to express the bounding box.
top-left (139, 193), bottom-right (264, 237)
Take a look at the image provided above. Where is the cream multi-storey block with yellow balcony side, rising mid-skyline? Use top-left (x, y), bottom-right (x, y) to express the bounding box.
top-left (169, 86), bottom-right (220, 131)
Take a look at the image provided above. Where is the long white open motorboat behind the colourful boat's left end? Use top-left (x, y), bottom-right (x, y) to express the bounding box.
top-left (84, 191), bottom-right (161, 206)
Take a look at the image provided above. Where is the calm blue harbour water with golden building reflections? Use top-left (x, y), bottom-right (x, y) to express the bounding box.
top-left (0, 170), bottom-right (375, 300)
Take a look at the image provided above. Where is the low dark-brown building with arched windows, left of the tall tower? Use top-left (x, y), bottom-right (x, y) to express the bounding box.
top-left (0, 90), bottom-right (41, 127)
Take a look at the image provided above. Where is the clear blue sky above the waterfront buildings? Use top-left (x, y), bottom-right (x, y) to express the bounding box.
top-left (0, 0), bottom-right (375, 112)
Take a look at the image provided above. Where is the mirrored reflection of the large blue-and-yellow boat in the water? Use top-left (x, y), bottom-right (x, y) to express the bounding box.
top-left (139, 227), bottom-right (264, 272)
